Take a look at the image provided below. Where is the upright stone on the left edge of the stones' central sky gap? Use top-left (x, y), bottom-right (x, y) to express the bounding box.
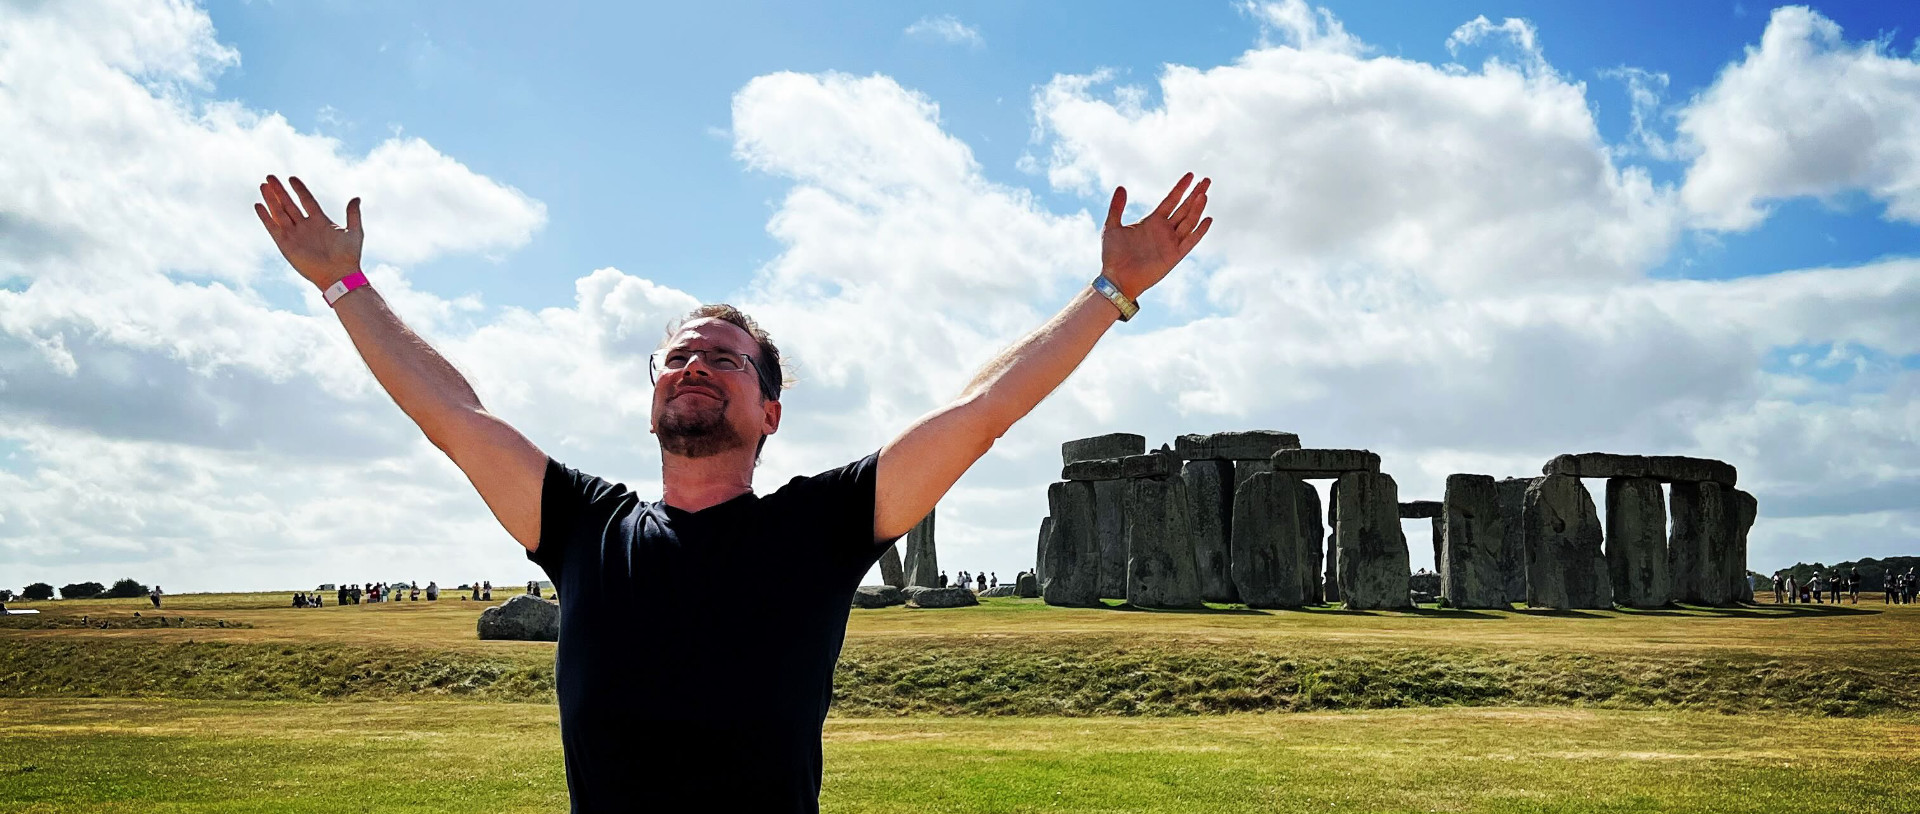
top-left (1334, 472), bottom-right (1413, 611)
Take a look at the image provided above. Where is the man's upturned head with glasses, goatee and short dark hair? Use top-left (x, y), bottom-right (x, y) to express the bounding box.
top-left (653, 319), bottom-right (780, 459)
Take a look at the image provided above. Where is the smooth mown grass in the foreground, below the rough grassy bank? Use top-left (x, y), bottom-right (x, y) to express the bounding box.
top-left (0, 699), bottom-right (1920, 814)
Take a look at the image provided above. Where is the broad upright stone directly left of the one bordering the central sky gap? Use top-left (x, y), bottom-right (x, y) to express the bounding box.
top-left (1231, 472), bottom-right (1319, 609)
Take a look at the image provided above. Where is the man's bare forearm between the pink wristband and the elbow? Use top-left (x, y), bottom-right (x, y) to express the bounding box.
top-left (334, 286), bottom-right (480, 443)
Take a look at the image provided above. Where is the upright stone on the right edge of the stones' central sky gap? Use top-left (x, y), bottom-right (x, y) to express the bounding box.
top-left (1436, 474), bottom-right (1511, 609)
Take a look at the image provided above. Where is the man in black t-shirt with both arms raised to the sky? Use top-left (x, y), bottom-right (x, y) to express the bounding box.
top-left (253, 173), bottom-right (1212, 812)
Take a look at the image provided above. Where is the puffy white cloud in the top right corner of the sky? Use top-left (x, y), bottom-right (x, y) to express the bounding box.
top-left (1678, 6), bottom-right (1920, 230)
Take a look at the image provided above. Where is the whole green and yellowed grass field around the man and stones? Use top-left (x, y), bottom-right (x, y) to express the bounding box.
top-left (0, 593), bottom-right (1920, 812)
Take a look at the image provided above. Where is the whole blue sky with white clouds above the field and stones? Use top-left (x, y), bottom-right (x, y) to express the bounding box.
top-left (0, 0), bottom-right (1920, 589)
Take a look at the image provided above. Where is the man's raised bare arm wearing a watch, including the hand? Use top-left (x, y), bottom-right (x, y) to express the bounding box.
top-left (874, 173), bottom-right (1213, 539)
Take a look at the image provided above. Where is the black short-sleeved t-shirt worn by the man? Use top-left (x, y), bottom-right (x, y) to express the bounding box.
top-left (526, 453), bottom-right (885, 812)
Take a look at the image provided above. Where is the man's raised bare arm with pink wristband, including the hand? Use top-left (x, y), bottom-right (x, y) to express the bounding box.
top-left (253, 175), bottom-right (547, 551)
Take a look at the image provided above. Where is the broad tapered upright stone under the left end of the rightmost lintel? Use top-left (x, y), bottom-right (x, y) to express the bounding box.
top-left (1521, 474), bottom-right (1613, 611)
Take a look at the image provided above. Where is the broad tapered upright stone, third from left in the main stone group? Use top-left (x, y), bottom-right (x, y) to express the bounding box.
top-left (1127, 478), bottom-right (1200, 609)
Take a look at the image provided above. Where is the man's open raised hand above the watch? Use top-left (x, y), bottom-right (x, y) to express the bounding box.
top-left (1100, 173), bottom-right (1213, 299)
